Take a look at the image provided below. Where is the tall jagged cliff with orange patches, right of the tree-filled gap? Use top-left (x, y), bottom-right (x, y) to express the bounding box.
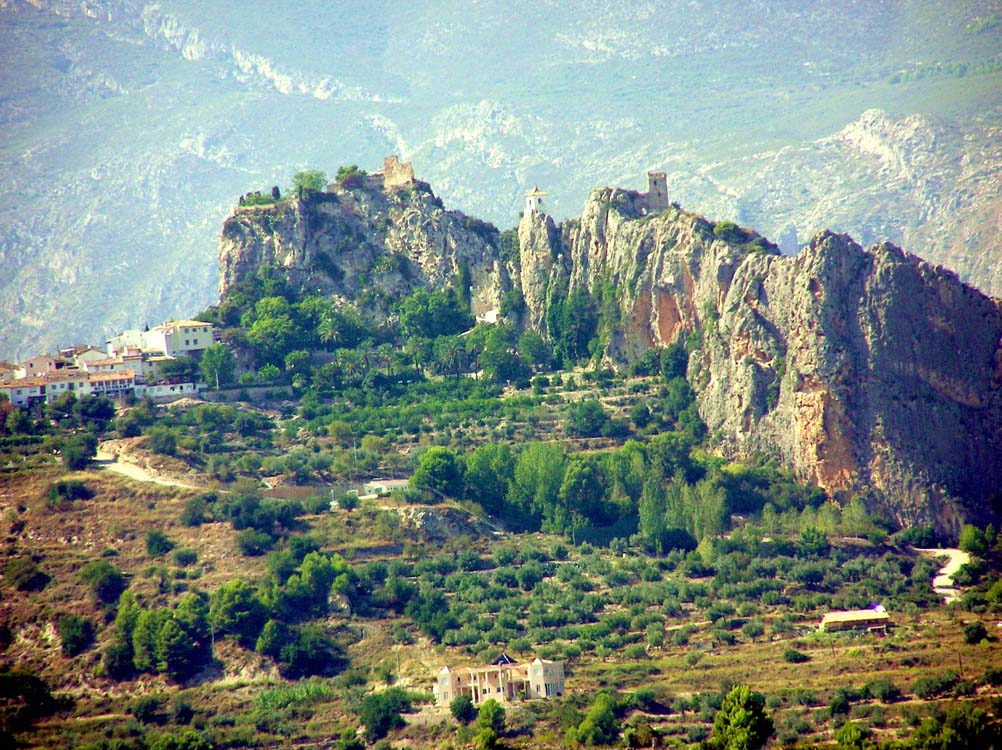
top-left (519, 193), bottom-right (1002, 531)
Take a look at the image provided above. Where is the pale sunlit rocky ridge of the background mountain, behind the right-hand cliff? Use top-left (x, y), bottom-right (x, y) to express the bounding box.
top-left (670, 110), bottom-right (1002, 295)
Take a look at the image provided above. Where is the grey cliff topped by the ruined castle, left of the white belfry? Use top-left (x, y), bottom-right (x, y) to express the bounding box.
top-left (219, 182), bottom-right (511, 314)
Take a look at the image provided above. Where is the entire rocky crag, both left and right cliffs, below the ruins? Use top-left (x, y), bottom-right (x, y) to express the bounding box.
top-left (219, 183), bottom-right (1002, 532)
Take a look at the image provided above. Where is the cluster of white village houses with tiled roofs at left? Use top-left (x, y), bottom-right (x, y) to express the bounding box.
top-left (0, 320), bottom-right (213, 408)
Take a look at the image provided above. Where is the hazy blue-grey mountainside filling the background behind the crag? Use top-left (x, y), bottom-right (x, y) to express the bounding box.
top-left (0, 0), bottom-right (1002, 358)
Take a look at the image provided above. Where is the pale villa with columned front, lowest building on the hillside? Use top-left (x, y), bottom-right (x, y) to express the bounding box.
top-left (434, 655), bottom-right (564, 706)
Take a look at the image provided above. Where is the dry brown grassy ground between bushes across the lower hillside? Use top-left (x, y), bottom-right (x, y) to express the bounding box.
top-left (0, 444), bottom-right (998, 747)
